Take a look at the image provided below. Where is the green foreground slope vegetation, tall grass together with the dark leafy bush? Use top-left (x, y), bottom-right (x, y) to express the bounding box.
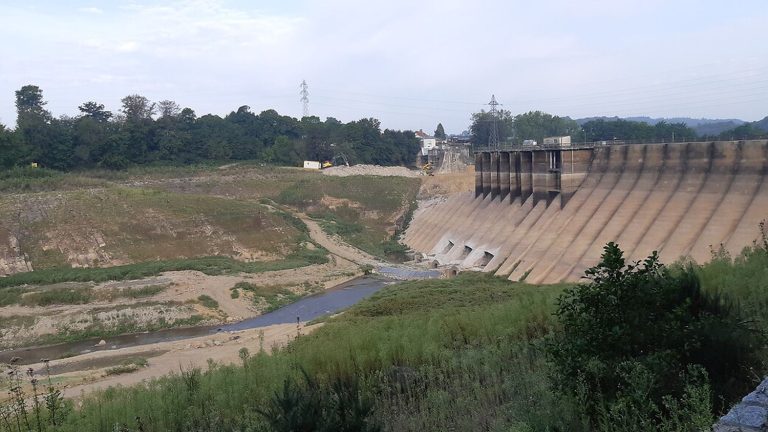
top-left (0, 228), bottom-right (768, 432)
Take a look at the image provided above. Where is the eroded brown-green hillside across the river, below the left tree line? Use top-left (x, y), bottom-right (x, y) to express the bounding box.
top-left (0, 164), bottom-right (419, 275)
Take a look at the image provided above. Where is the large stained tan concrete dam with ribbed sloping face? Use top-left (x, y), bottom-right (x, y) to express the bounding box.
top-left (403, 140), bottom-right (768, 283)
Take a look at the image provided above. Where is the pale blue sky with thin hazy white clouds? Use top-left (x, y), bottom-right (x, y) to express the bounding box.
top-left (0, 0), bottom-right (768, 133)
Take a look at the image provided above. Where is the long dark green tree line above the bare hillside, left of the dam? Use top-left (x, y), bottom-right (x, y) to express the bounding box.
top-left (0, 85), bottom-right (419, 170)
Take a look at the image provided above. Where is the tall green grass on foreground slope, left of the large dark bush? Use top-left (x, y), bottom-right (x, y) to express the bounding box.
top-left (49, 274), bottom-right (580, 431)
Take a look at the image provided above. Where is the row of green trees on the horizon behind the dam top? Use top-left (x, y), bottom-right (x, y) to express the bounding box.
top-left (470, 110), bottom-right (768, 146)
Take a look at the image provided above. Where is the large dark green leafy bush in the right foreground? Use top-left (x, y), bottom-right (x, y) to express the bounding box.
top-left (547, 243), bottom-right (765, 430)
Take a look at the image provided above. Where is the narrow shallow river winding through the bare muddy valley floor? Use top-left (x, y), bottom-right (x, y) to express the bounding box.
top-left (0, 276), bottom-right (397, 364)
